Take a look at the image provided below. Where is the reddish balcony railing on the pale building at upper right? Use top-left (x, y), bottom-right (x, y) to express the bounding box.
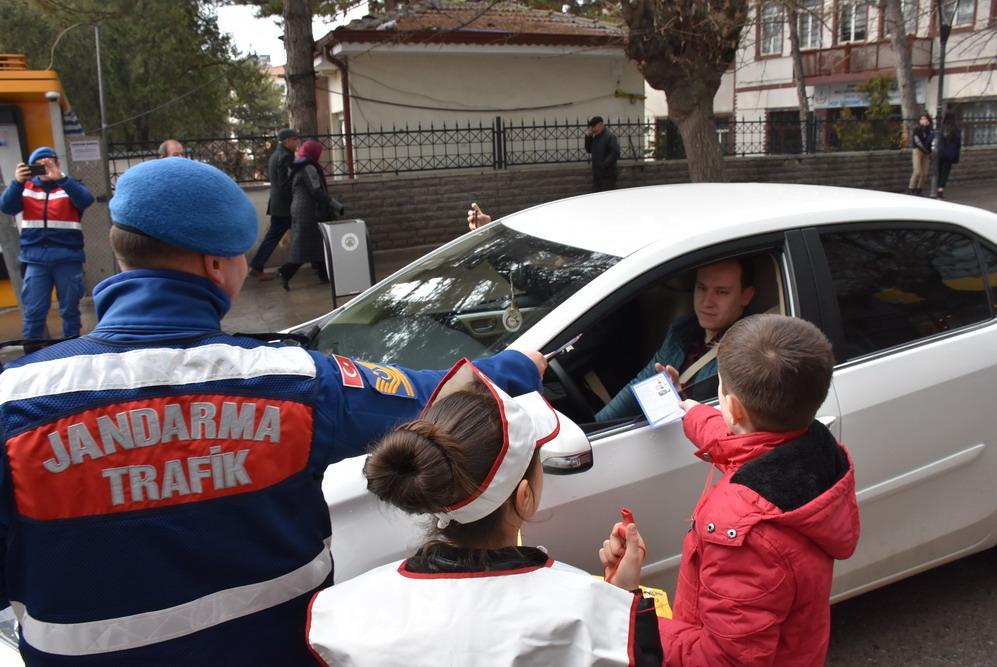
top-left (803, 37), bottom-right (933, 79)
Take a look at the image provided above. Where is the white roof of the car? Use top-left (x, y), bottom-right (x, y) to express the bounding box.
top-left (502, 183), bottom-right (997, 257)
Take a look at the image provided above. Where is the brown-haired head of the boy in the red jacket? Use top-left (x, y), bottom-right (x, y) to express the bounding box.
top-left (717, 315), bottom-right (834, 431)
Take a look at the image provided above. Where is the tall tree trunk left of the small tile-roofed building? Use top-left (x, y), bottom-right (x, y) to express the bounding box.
top-left (284, 0), bottom-right (318, 137)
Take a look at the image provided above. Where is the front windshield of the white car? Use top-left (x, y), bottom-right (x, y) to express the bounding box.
top-left (315, 223), bottom-right (619, 368)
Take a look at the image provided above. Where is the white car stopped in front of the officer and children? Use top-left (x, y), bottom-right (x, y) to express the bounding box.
top-left (312, 184), bottom-right (997, 600)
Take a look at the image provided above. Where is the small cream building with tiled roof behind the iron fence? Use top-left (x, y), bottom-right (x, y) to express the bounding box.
top-left (316, 0), bottom-right (644, 176)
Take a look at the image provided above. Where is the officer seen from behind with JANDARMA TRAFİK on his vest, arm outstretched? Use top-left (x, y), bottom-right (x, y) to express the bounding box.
top-left (0, 158), bottom-right (543, 665)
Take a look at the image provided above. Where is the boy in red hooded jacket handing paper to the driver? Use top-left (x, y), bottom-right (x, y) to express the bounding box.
top-left (610, 315), bottom-right (859, 667)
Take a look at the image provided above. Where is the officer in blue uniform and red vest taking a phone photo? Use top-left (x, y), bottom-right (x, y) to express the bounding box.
top-left (0, 146), bottom-right (93, 340)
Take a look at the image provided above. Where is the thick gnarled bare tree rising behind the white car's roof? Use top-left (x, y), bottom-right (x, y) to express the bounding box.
top-left (622, 0), bottom-right (748, 182)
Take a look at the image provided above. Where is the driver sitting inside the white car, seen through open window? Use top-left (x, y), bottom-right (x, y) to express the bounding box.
top-left (595, 258), bottom-right (755, 421)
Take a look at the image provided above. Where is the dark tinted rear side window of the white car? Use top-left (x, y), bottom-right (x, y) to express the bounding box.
top-left (821, 228), bottom-right (991, 361)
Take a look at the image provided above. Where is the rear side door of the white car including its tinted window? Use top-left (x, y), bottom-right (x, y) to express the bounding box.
top-left (805, 222), bottom-right (997, 596)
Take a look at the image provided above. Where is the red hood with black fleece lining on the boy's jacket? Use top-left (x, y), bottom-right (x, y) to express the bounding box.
top-left (729, 422), bottom-right (860, 560)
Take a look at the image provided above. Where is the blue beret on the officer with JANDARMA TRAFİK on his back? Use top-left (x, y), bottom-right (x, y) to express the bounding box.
top-left (110, 157), bottom-right (259, 257)
